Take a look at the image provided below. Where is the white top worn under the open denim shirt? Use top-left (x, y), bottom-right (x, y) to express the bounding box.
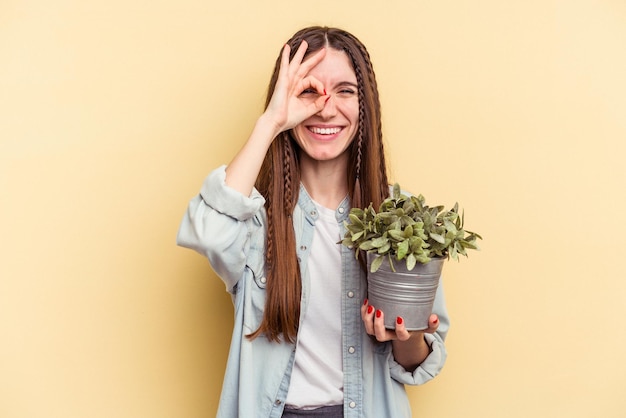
top-left (286, 203), bottom-right (343, 409)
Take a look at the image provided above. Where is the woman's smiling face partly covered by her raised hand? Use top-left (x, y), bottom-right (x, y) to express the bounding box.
top-left (293, 48), bottom-right (359, 165)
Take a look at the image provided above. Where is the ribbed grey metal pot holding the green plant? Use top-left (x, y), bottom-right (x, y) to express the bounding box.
top-left (367, 254), bottom-right (446, 331)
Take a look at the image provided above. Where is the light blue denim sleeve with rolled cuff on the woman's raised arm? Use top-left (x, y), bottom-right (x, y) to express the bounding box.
top-left (176, 166), bottom-right (265, 291)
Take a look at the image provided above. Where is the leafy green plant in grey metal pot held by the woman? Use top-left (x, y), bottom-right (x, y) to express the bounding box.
top-left (340, 183), bottom-right (482, 330)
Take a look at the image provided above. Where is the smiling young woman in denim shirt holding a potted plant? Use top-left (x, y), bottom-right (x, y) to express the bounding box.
top-left (178, 27), bottom-right (448, 418)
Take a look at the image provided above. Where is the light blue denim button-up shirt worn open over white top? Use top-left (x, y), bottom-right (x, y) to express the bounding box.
top-left (177, 166), bottom-right (449, 418)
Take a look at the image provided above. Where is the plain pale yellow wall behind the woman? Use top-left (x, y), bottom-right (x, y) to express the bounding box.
top-left (0, 0), bottom-right (626, 418)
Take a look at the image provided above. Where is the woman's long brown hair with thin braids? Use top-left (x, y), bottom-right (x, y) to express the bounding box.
top-left (248, 26), bottom-right (389, 342)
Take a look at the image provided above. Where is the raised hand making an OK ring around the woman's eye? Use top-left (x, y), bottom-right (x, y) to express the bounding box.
top-left (263, 41), bottom-right (327, 134)
